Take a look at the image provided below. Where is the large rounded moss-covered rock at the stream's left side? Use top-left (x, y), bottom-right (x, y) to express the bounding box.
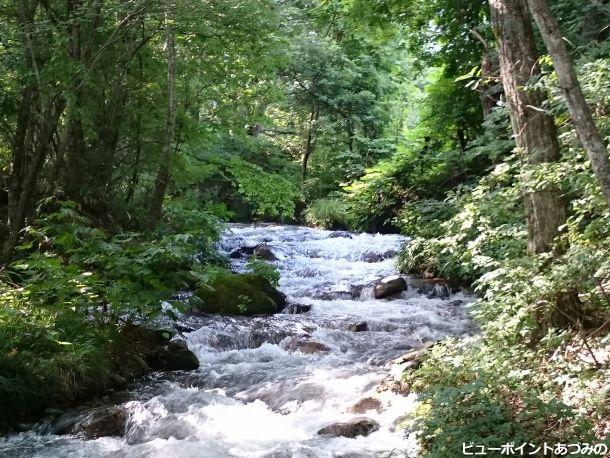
top-left (193, 273), bottom-right (286, 315)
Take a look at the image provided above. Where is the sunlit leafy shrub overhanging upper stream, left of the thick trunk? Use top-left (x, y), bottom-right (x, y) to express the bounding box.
top-left (400, 156), bottom-right (526, 283)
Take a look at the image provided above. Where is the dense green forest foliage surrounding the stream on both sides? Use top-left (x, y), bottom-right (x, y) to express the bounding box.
top-left (0, 0), bottom-right (610, 450)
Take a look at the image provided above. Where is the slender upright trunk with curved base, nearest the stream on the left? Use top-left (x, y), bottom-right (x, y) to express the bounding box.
top-left (147, 0), bottom-right (176, 229)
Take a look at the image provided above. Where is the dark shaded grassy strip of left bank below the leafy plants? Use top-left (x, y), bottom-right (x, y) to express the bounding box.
top-left (0, 323), bottom-right (199, 434)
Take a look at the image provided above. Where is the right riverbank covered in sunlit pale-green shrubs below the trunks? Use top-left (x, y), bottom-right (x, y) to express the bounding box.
top-left (400, 188), bottom-right (610, 457)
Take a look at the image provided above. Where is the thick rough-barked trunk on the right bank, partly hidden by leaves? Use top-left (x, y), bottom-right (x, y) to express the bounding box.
top-left (489, 0), bottom-right (565, 253)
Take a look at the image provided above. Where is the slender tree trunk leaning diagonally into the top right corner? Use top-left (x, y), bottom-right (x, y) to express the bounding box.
top-left (527, 0), bottom-right (610, 207)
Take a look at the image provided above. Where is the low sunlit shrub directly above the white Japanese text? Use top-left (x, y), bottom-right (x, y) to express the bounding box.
top-left (405, 335), bottom-right (604, 458)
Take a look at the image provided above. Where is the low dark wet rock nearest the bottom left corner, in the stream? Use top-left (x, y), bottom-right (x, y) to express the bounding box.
top-left (53, 406), bottom-right (127, 439)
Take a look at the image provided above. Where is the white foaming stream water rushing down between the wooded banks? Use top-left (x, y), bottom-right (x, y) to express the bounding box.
top-left (0, 225), bottom-right (469, 458)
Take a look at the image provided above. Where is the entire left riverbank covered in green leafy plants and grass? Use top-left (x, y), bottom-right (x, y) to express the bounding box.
top-left (0, 202), bottom-right (219, 429)
